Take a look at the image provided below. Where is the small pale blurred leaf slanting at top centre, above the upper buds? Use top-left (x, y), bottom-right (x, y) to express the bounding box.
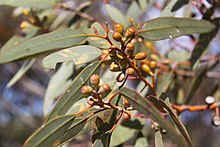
top-left (105, 4), bottom-right (129, 27)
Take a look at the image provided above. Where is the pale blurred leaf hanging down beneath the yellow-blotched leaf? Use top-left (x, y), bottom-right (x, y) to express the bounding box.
top-left (43, 62), bottom-right (74, 116)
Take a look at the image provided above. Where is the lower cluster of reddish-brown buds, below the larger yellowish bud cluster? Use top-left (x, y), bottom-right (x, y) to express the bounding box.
top-left (81, 74), bottom-right (111, 106)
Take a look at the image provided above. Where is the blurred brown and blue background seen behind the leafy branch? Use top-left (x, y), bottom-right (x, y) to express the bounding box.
top-left (0, 0), bottom-right (220, 147)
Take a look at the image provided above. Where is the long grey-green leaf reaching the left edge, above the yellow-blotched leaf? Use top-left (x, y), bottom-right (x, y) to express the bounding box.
top-left (0, 29), bottom-right (86, 63)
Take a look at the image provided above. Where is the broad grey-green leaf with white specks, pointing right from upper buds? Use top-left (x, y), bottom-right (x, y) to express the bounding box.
top-left (138, 17), bottom-right (214, 41)
